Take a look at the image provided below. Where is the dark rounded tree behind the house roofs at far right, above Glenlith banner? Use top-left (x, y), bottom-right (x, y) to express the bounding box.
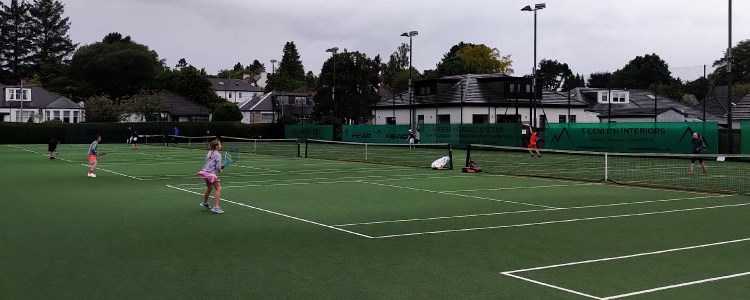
top-left (610, 54), bottom-right (676, 89)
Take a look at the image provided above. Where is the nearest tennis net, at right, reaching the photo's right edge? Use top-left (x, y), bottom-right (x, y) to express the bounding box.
top-left (466, 145), bottom-right (750, 194)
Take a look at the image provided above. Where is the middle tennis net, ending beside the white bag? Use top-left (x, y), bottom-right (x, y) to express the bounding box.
top-left (305, 139), bottom-right (453, 169)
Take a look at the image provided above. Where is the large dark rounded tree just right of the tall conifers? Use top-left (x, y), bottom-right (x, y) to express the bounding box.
top-left (70, 33), bottom-right (164, 99)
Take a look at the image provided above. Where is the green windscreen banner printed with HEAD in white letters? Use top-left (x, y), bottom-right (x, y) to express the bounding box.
top-left (341, 125), bottom-right (409, 144)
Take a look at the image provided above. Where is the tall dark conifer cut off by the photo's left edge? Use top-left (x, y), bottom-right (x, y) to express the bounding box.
top-left (0, 0), bottom-right (34, 81)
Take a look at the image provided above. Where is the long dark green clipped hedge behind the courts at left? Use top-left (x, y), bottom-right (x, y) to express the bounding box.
top-left (0, 122), bottom-right (284, 144)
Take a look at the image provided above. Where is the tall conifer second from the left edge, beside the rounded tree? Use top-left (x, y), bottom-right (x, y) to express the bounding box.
top-left (29, 0), bottom-right (78, 75)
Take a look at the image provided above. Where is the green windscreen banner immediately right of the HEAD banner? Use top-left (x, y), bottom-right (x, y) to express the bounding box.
top-left (419, 123), bottom-right (521, 147)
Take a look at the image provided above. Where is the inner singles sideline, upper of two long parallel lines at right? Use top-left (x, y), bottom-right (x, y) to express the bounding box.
top-left (333, 195), bottom-right (735, 227)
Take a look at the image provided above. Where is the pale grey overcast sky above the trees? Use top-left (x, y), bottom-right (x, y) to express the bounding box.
top-left (63, 0), bottom-right (750, 78)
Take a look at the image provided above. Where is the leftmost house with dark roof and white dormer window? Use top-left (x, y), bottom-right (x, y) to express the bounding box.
top-left (0, 85), bottom-right (85, 123)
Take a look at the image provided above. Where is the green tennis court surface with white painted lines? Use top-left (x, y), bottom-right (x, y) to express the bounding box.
top-left (0, 140), bottom-right (750, 299)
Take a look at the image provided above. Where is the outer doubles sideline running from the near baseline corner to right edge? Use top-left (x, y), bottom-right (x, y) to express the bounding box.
top-left (373, 203), bottom-right (750, 239)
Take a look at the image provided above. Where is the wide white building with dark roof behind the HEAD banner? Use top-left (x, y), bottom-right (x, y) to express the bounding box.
top-left (372, 74), bottom-right (599, 127)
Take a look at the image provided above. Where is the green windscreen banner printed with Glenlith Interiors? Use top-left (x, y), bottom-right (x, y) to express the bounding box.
top-left (544, 122), bottom-right (719, 153)
